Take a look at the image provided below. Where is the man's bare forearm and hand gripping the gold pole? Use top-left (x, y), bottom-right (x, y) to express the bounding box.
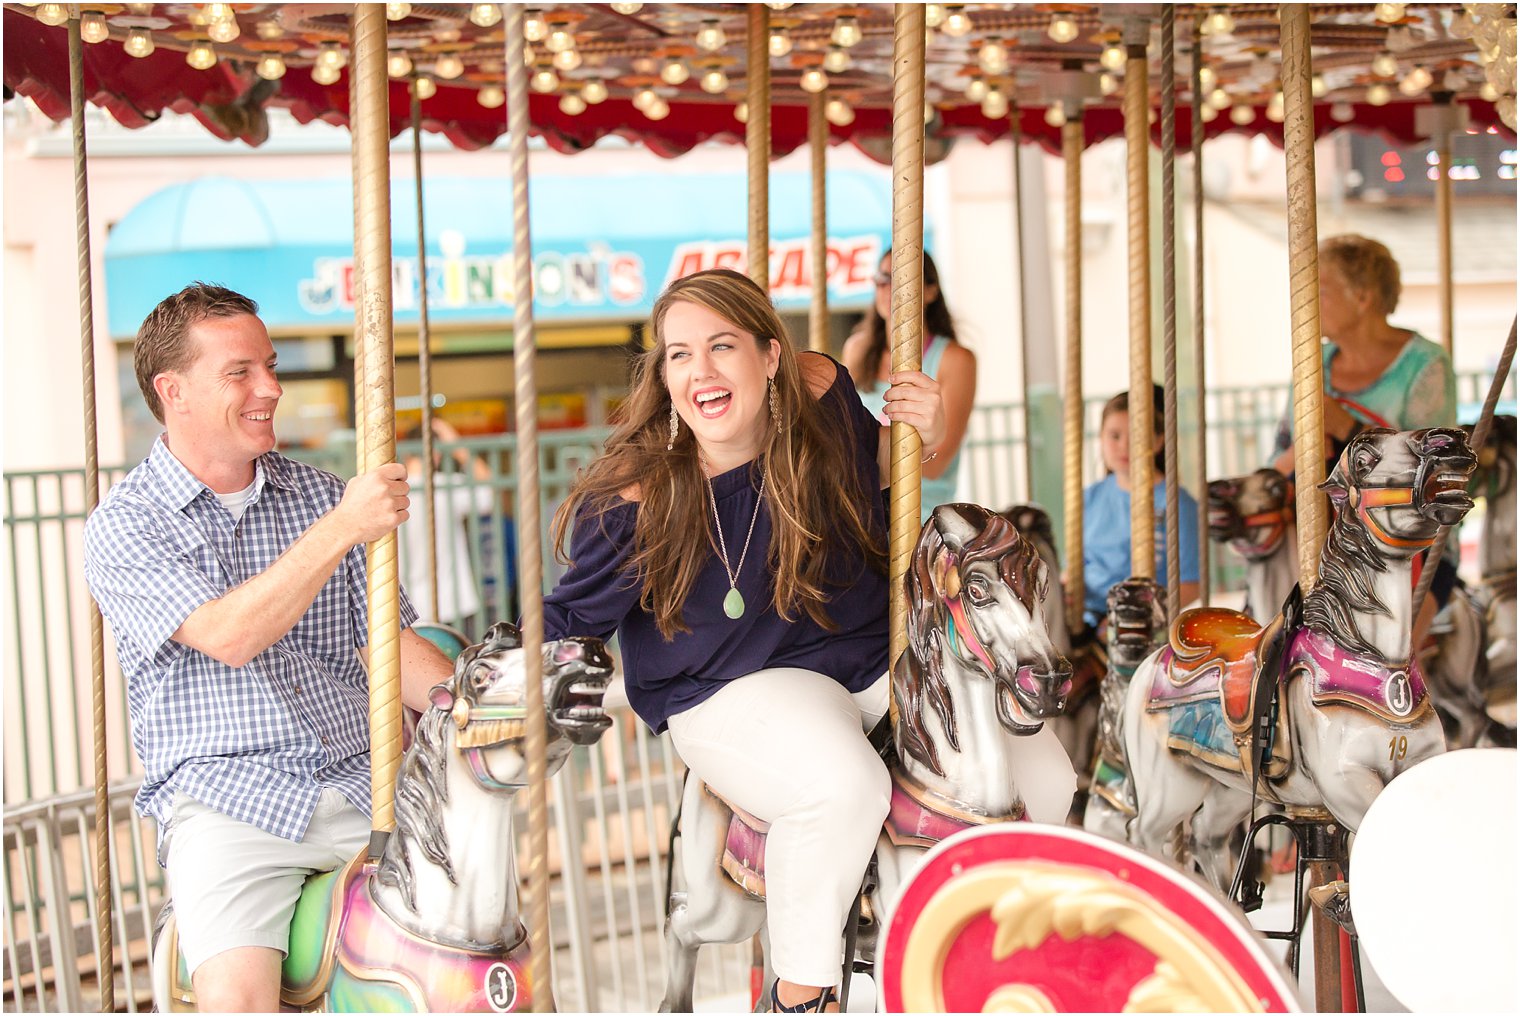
top-left (170, 462), bottom-right (410, 669)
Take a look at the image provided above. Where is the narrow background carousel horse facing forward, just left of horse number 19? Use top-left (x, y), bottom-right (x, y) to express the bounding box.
top-left (1082, 578), bottom-right (1166, 840)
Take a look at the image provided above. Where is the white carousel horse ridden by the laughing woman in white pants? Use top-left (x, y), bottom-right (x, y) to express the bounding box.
top-left (661, 505), bottom-right (1075, 1011)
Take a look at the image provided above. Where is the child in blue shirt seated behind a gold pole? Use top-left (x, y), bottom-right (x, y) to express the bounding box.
top-left (1082, 385), bottom-right (1198, 628)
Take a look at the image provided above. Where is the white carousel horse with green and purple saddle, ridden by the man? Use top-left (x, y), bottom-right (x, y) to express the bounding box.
top-left (154, 624), bottom-right (614, 1013)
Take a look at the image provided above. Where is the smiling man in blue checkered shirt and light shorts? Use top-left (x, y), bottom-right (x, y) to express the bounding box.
top-left (85, 283), bottom-right (453, 1011)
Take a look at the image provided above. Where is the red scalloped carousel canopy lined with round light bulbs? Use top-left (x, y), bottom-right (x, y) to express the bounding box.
top-left (5, 3), bottom-right (1515, 161)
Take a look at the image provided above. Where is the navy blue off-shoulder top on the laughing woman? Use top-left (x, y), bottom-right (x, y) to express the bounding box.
top-left (544, 362), bottom-right (888, 733)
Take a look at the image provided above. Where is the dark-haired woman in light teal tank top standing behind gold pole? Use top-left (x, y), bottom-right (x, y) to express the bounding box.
top-left (844, 254), bottom-right (976, 520)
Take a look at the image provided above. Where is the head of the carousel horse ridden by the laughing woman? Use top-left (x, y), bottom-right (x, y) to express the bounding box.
top-left (903, 505), bottom-right (1072, 772)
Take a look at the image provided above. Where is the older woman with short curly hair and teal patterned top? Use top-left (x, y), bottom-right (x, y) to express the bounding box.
top-left (1272, 234), bottom-right (1456, 646)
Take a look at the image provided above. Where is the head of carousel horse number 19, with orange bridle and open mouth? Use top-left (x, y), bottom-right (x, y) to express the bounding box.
top-left (1319, 427), bottom-right (1477, 558)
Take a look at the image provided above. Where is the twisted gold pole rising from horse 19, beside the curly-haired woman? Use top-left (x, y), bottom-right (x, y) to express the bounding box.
top-left (1278, 3), bottom-right (1339, 587)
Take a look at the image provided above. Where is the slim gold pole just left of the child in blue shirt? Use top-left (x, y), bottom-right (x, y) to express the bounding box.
top-left (1061, 108), bottom-right (1087, 633)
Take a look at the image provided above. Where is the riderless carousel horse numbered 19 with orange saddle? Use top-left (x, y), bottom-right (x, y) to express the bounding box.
top-left (1123, 427), bottom-right (1474, 891)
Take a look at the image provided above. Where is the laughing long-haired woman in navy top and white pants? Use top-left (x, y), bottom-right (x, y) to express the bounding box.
top-left (544, 269), bottom-right (945, 1011)
